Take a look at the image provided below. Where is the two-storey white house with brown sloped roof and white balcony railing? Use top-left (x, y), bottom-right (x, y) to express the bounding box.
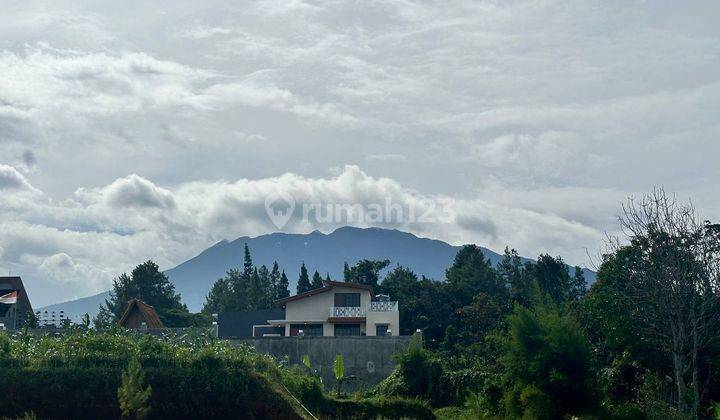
top-left (253, 281), bottom-right (400, 337)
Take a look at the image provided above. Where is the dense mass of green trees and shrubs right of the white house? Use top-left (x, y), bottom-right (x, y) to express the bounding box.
top-left (367, 190), bottom-right (720, 419)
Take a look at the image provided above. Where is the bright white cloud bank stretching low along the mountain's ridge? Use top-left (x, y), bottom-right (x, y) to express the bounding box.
top-left (0, 165), bottom-right (602, 303)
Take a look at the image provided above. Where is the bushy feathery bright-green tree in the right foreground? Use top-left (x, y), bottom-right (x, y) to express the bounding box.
top-left (501, 286), bottom-right (592, 419)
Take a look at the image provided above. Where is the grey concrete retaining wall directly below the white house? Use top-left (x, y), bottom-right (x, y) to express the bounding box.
top-left (231, 336), bottom-right (411, 391)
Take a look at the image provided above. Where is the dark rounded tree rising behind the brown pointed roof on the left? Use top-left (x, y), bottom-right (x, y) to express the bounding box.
top-left (103, 261), bottom-right (190, 327)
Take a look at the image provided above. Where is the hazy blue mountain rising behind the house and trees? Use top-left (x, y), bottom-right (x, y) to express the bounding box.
top-left (41, 227), bottom-right (595, 318)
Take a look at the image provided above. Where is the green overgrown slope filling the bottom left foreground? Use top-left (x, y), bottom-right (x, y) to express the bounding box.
top-left (0, 327), bottom-right (433, 419)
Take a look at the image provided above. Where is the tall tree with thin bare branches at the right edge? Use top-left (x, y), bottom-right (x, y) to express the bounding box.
top-left (615, 189), bottom-right (720, 417)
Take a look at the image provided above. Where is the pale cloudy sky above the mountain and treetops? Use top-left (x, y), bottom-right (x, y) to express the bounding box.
top-left (0, 0), bottom-right (720, 306)
